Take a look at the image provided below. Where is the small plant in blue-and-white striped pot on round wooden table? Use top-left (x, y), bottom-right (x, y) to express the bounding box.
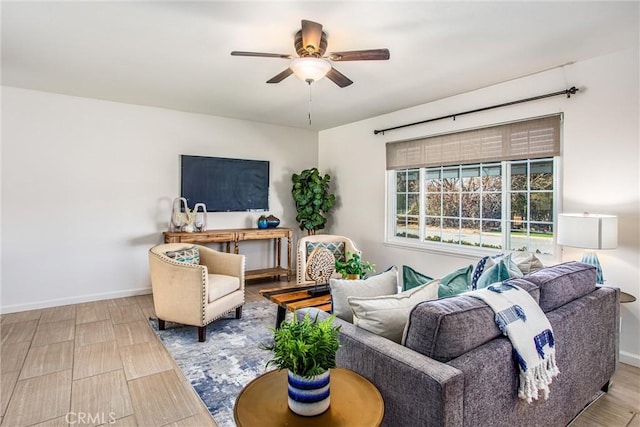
top-left (265, 313), bottom-right (340, 416)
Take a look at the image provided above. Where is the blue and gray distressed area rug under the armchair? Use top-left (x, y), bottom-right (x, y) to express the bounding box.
top-left (149, 300), bottom-right (290, 427)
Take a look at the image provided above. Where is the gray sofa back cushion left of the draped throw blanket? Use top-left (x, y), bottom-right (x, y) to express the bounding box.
top-left (403, 279), bottom-right (540, 362)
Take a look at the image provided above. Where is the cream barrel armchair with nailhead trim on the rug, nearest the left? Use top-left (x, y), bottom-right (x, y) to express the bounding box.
top-left (149, 243), bottom-right (245, 342)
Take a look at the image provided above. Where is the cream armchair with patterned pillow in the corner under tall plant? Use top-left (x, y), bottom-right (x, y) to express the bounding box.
top-left (296, 234), bottom-right (360, 285)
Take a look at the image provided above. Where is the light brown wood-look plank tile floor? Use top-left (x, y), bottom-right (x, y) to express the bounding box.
top-left (0, 282), bottom-right (640, 427)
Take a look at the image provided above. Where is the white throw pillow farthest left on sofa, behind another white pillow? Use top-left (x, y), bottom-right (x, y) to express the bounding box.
top-left (329, 266), bottom-right (398, 323)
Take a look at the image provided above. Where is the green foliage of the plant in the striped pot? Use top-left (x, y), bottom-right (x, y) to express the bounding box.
top-left (264, 313), bottom-right (340, 377)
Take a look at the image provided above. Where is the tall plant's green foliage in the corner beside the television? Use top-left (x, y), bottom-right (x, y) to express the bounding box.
top-left (291, 168), bottom-right (336, 235)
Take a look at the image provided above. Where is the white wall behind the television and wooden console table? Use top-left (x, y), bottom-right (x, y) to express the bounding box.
top-left (0, 87), bottom-right (318, 313)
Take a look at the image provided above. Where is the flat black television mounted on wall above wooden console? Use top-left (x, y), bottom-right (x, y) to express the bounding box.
top-left (180, 155), bottom-right (269, 212)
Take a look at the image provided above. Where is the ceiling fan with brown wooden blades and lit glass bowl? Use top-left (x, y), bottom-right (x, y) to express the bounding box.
top-left (231, 19), bottom-right (389, 87)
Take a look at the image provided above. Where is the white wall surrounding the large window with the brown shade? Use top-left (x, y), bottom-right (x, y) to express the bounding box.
top-left (319, 49), bottom-right (640, 366)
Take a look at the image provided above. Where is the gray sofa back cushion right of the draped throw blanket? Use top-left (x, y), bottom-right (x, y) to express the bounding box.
top-left (525, 261), bottom-right (596, 312)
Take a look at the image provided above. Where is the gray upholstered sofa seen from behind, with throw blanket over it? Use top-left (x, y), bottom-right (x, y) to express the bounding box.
top-left (298, 262), bottom-right (620, 427)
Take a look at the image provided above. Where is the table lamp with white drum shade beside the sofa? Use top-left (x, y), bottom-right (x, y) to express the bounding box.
top-left (558, 212), bottom-right (618, 285)
